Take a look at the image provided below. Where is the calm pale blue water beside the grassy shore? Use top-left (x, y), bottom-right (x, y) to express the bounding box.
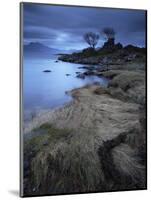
top-left (23, 56), bottom-right (108, 118)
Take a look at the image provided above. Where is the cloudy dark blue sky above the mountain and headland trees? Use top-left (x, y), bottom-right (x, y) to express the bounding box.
top-left (23, 3), bottom-right (146, 50)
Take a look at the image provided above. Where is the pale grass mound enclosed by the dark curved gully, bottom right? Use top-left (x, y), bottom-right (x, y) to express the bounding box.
top-left (112, 144), bottom-right (146, 189)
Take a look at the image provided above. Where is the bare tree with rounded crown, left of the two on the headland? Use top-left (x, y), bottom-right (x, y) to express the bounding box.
top-left (84, 32), bottom-right (100, 48)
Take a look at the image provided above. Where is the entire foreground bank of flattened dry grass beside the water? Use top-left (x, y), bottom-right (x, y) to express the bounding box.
top-left (24, 67), bottom-right (146, 195)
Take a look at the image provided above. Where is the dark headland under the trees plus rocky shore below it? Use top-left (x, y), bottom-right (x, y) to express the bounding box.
top-left (58, 44), bottom-right (146, 79)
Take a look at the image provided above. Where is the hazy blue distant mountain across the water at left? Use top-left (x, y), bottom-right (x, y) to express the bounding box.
top-left (24, 42), bottom-right (79, 58)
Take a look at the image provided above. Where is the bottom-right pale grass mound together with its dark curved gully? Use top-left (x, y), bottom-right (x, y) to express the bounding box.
top-left (98, 134), bottom-right (146, 191)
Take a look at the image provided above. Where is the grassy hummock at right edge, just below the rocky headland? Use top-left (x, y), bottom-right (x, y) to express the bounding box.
top-left (104, 70), bottom-right (146, 104)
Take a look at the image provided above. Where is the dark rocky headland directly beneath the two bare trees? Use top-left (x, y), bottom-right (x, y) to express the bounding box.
top-left (58, 45), bottom-right (146, 66)
